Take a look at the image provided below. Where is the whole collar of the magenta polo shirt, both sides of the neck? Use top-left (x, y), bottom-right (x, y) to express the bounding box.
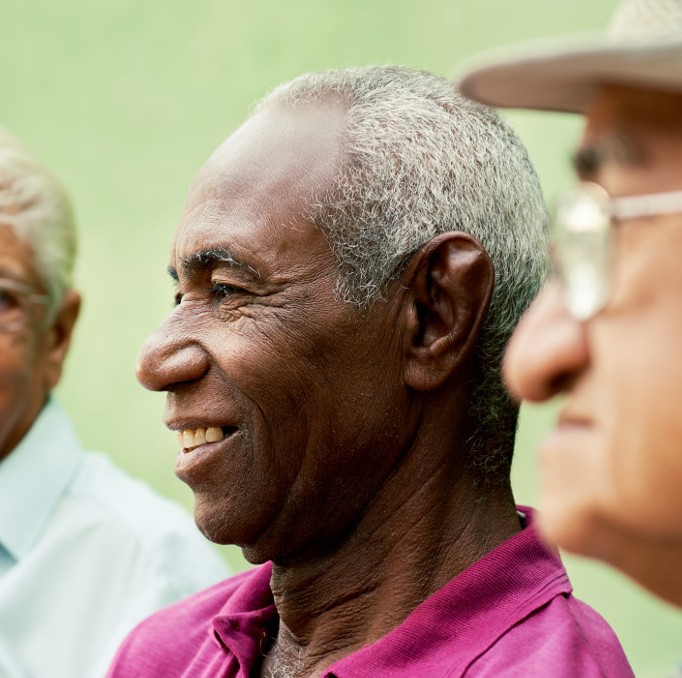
top-left (211, 506), bottom-right (572, 678)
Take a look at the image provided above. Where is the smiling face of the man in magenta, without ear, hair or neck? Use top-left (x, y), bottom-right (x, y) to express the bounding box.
top-left (138, 103), bottom-right (408, 562)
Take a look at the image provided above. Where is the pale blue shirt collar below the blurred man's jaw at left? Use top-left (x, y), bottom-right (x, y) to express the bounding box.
top-left (0, 398), bottom-right (81, 560)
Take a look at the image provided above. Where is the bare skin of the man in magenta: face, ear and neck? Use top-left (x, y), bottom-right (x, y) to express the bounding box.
top-left (138, 102), bottom-right (519, 676)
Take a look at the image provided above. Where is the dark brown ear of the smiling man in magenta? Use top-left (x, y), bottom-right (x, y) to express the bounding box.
top-left (403, 231), bottom-right (495, 391)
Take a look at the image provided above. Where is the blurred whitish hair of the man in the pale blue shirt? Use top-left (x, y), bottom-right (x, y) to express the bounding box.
top-left (0, 130), bottom-right (76, 312)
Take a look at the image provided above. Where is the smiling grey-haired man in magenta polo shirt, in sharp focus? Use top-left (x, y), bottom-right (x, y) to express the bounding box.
top-left (110, 68), bottom-right (631, 678)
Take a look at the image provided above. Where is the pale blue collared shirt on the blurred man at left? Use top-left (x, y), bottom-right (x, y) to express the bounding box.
top-left (0, 401), bottom-right (229, 678)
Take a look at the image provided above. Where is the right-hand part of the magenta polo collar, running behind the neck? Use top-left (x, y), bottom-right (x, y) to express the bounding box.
top-left (324, 506), bottom-right (573, 678)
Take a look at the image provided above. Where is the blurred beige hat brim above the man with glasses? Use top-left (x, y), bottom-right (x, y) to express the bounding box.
top-left (457, 37), bottom-right (682, 113)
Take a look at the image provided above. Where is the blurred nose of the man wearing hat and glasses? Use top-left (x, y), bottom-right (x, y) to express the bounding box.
top-left (503, 281), bottom-right (589, 402)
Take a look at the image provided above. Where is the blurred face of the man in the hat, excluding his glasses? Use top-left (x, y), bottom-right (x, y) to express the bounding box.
top-left (505, 87), bottom-right (682, 560)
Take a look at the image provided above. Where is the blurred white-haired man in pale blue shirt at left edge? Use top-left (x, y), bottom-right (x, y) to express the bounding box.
top-left (0, 136), bottom-right (226, 678)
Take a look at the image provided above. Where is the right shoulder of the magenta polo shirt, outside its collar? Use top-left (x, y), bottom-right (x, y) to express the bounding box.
top-left (465, 594), bottom-right (634, 678)
